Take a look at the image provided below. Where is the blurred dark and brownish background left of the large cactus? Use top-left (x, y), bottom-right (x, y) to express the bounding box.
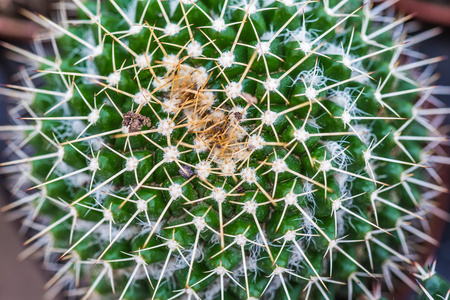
top-left (0, 0), bottom-right (50, 300)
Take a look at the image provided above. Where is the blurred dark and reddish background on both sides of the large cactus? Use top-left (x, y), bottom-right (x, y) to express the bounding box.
top-left (0, 0), bottom-right (450, 300)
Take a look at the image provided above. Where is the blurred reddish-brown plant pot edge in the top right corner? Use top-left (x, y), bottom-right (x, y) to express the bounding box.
top-left (397, 0), bottom-right (450, 26)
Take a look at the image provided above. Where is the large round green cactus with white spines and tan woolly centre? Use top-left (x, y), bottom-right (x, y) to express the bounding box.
top-left (1, 0), bottom-right (449, 300)
